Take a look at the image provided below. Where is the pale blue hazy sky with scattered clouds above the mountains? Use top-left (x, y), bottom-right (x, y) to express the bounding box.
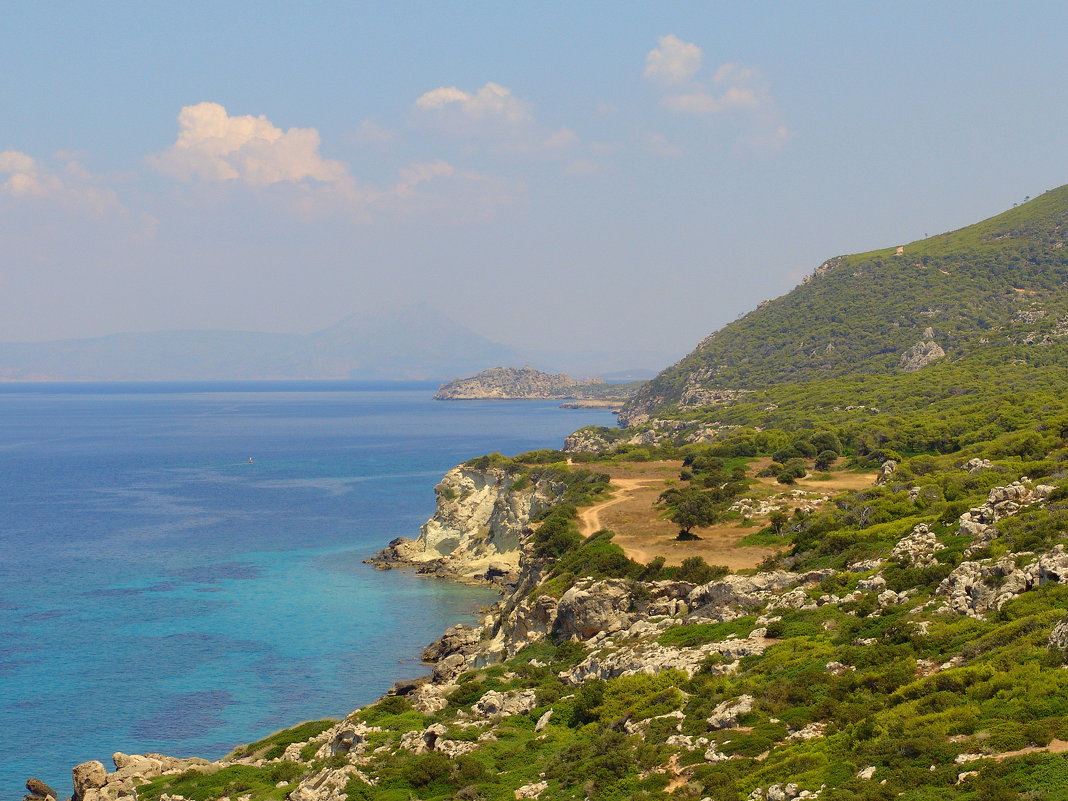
top-left (0, 0), bottom-right (1068, 366)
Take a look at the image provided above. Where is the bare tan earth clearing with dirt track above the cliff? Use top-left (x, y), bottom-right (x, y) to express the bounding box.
top-left (579, 459), bottom-right (876, 570)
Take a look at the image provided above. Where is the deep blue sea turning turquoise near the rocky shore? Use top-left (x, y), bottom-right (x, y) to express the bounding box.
top-left (0, 382), bottom-right (614, 799)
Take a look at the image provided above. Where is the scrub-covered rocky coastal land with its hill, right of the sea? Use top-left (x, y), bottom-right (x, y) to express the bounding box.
top-left (43, 187), bottom-right (1068, 801)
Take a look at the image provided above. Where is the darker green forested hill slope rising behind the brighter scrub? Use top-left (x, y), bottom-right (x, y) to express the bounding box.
top-left (624, 187), bottom-right (1068, 421)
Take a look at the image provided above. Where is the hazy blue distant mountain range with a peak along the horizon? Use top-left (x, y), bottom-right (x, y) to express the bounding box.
top-left (0, 303), bottom-right (671, 381)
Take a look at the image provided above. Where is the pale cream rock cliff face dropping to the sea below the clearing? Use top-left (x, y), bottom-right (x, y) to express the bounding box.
top-left (373, 465), bottom-right (564, 583)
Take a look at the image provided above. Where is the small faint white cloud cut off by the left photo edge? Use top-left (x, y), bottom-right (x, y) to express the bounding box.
top-left (0, 151), bottom-right (122, 216)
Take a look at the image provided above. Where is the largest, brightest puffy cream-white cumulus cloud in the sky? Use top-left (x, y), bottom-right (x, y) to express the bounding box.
top-left (151, 103), bottom-right (351, 187)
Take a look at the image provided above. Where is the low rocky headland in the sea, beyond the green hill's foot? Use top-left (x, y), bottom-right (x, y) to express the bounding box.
top-left (434, 366), bottom-right (642, 407)
